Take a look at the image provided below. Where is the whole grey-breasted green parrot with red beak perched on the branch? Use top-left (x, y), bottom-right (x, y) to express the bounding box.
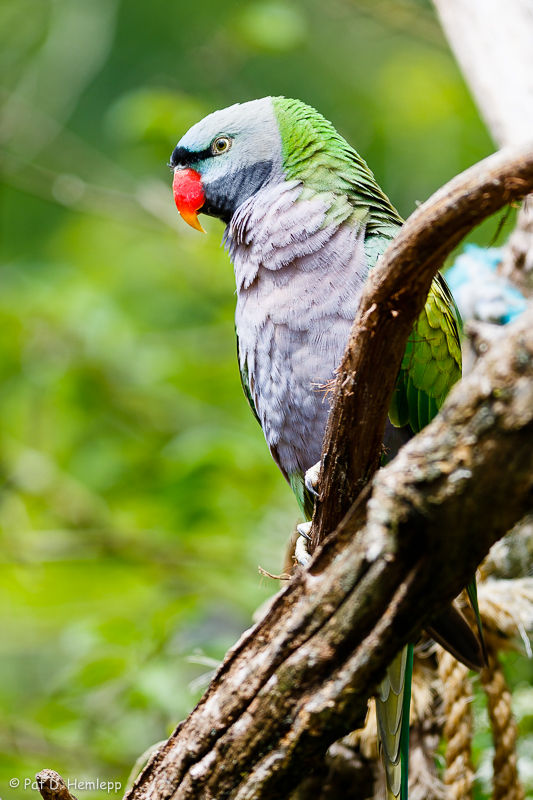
top-left (169, 97), bottom-right (484, 800)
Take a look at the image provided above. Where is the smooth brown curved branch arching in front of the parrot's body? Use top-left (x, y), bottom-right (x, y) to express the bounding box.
top-left (313, 139), bottom-right (533, 545)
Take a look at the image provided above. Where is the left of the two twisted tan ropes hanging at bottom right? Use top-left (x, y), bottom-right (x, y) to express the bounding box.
top-left (437, 647), bottom-right (474, 800)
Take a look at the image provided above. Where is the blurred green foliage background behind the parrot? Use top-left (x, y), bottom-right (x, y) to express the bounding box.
top-left (0, 0), bottom-right (533, 800)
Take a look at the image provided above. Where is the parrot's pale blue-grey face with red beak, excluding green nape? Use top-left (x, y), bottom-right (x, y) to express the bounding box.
top-left (169, 97), bottom-right (282, 231)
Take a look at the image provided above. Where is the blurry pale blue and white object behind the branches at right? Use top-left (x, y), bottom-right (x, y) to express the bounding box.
top-left (446, 244), bottom-right (527, 325)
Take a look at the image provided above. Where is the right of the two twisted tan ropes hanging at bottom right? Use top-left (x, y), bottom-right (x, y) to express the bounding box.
top-left (480, 648), bottom-right (524, 800)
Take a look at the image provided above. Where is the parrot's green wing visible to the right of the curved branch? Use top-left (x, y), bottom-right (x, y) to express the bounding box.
top-left (389, 273), bottom-right (461, 433)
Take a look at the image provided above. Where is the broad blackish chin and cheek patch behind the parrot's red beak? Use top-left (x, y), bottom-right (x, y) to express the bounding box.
top-left (201, 161), bottom-right (273, 224)
